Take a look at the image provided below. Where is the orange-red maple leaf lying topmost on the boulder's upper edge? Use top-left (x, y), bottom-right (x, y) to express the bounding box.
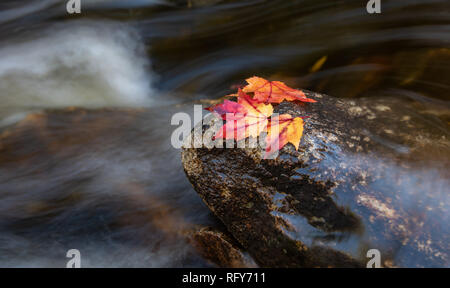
top-left (243, 76), bottom-right (317, 103)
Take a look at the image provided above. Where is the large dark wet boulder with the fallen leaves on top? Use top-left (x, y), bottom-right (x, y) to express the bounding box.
top-left (182, 92), bottom-right (450, 267)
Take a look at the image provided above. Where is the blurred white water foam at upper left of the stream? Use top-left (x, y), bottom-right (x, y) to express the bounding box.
top-left (0, 21), bottom-right (154, 124)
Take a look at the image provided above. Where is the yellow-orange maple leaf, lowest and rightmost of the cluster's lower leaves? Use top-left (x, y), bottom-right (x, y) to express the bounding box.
top-left (266, 114), bottom-right (303, 155)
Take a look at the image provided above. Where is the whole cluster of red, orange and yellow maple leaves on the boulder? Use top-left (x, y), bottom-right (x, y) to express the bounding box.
top-left (206, 77), bottom-right (316, 153)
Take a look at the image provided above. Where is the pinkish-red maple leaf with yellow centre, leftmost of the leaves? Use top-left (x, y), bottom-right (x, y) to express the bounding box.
top-left (206, 89), bottom-right (273, 141)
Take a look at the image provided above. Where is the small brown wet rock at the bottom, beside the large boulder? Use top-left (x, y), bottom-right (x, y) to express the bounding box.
top-left (190, 227), bottom-right (257, 268)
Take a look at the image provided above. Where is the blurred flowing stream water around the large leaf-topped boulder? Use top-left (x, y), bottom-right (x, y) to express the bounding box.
top-left (0, 0), bottom-right (450, 267)
